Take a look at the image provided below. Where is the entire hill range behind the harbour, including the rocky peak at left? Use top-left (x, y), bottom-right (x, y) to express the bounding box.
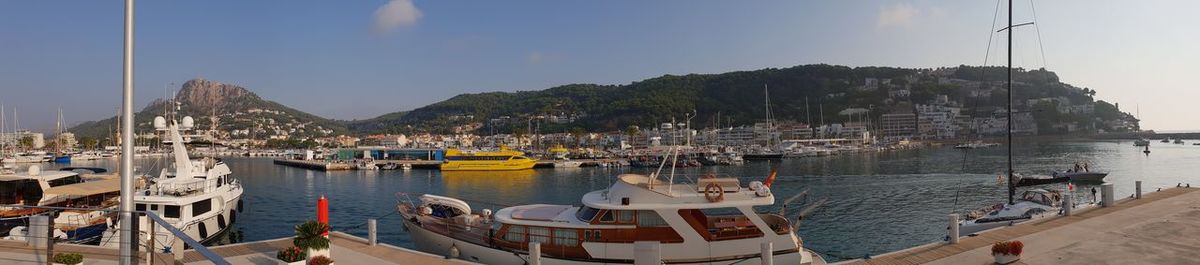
top-left (71, 65), bottom-right (1136, 140)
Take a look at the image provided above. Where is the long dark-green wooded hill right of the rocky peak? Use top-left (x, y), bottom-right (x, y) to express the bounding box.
top-left (348, 65), bottom-right (1136, 133)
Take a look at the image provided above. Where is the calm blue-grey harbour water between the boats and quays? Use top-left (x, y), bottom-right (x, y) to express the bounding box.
top-left (60, 140), bottom-right (1200, 260)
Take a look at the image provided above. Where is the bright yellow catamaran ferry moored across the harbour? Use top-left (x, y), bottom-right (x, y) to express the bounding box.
top-left (442, 146), bottom-right (538, 170)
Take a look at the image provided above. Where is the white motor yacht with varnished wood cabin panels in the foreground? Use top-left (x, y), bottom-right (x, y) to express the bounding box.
top-left (398, 174), bottom-right (824, 265)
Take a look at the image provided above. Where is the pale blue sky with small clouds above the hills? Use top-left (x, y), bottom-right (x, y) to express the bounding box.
top-left (0, 0), bottom-right (1200, 132)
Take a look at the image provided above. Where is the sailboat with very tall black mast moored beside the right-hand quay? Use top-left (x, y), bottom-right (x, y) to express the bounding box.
top-left (959, 0), bottom-right (1063, 235)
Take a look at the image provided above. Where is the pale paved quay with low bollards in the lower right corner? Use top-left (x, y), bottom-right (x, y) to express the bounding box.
top-left (850, 187), bottom-right (1200, 264)
